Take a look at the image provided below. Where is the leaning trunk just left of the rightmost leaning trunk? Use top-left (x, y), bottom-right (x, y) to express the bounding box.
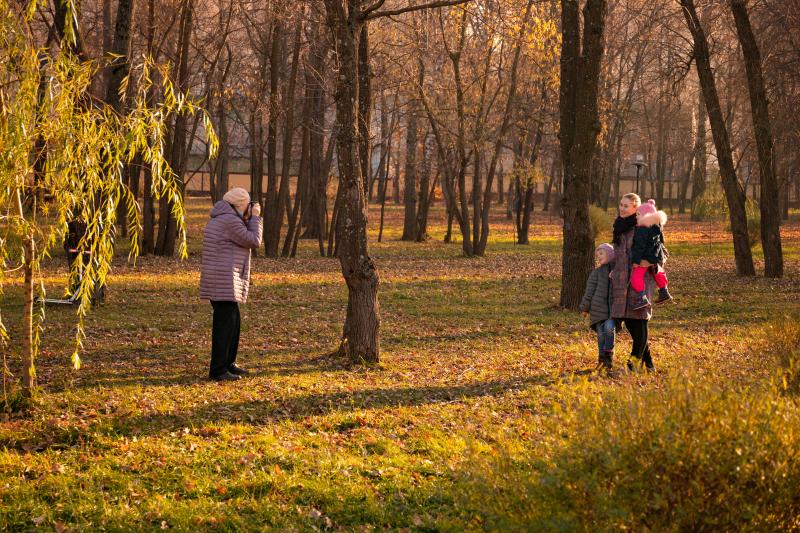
top-left (681, 0), bottom-right (755, 276)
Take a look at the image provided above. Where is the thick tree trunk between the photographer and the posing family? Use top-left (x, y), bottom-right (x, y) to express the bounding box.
top-left (325, 0), bottom-right (380, 363)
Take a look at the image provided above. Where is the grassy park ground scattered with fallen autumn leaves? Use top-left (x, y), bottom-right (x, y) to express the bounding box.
top-left (0, 199), bottom-right (800, 531)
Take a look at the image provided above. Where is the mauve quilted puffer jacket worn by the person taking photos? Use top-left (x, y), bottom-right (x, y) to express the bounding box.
top-left (200, 200), bottom-right (263, 303)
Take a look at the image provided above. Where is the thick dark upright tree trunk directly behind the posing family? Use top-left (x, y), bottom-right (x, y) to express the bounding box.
top-left (559, 0), bottom-right (606, 309)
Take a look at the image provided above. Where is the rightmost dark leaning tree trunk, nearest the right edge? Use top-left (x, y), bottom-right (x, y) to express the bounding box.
top-left (731, 0), bottom-right (783, 278)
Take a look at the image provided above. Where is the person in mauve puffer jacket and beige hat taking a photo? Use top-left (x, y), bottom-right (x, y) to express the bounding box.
top-left (200, 187), bottom-right (262, 381)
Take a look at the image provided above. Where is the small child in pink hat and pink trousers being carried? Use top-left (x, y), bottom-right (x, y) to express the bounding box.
top-left (631, 199), bottom-right (672, 310)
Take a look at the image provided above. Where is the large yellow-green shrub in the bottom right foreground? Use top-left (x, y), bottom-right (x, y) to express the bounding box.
top-left (464, 320), bottom-right (800, 531)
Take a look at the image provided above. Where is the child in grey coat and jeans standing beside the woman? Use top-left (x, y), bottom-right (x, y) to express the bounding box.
top-left (580, 243), bottom-right (616, 371)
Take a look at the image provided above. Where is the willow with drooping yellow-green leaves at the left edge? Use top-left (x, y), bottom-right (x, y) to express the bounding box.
top-left (0, 0), bottom-right (216, 397)
